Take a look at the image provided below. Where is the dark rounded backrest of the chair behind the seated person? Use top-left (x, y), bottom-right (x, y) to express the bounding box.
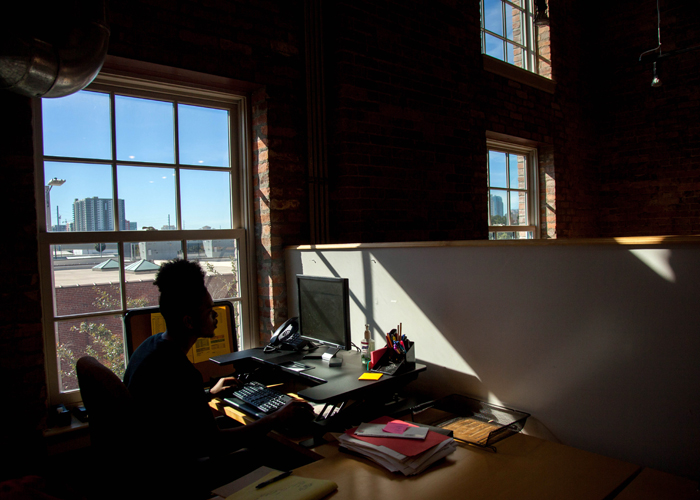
top-left (76, 356), bottom-right (136, 454)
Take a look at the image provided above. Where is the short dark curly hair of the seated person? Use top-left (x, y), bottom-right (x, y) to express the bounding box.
top-left (153, 259), bottom-right (207, 328)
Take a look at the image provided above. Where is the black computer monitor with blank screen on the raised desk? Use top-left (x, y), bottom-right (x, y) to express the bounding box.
top-left (297, 275), bottom-right (352, 350)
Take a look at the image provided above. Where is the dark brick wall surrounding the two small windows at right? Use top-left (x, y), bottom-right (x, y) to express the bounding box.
top-left (325, 0), bottom-right (600, 242)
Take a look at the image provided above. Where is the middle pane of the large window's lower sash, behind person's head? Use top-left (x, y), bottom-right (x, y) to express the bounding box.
top-left (124, 241), bottom-right (161, 309)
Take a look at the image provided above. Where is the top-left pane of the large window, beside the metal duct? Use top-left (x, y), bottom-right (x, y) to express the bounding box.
top-left (41, 91), bottom-right (112, 160)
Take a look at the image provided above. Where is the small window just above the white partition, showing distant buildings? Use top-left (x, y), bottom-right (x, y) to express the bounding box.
top-left (487, 141), bottom-right (539, 240)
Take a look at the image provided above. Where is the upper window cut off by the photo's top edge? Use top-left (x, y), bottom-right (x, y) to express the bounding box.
top-left (481, 0), bottom-right (552, 78)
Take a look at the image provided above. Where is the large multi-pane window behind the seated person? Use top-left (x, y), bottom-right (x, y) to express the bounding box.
top-left (36, 75), bottom-right (249, 402)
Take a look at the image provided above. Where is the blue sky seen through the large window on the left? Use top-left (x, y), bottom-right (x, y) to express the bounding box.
top-left (42, 91), bottom-right (231, 229)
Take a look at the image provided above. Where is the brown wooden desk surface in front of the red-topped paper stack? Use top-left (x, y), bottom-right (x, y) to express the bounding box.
top-left (295, 434), bottom-right (639, 500)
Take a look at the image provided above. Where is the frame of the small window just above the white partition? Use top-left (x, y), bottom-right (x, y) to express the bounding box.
top-left (486, 139), bottom-right (541, 241)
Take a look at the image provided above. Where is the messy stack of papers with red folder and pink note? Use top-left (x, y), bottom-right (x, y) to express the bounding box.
top-left (338, 417), bottom-right (456, 476)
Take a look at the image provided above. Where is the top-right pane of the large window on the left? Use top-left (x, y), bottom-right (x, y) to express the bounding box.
top-left (178, 104), bottom-right (230, 167)
